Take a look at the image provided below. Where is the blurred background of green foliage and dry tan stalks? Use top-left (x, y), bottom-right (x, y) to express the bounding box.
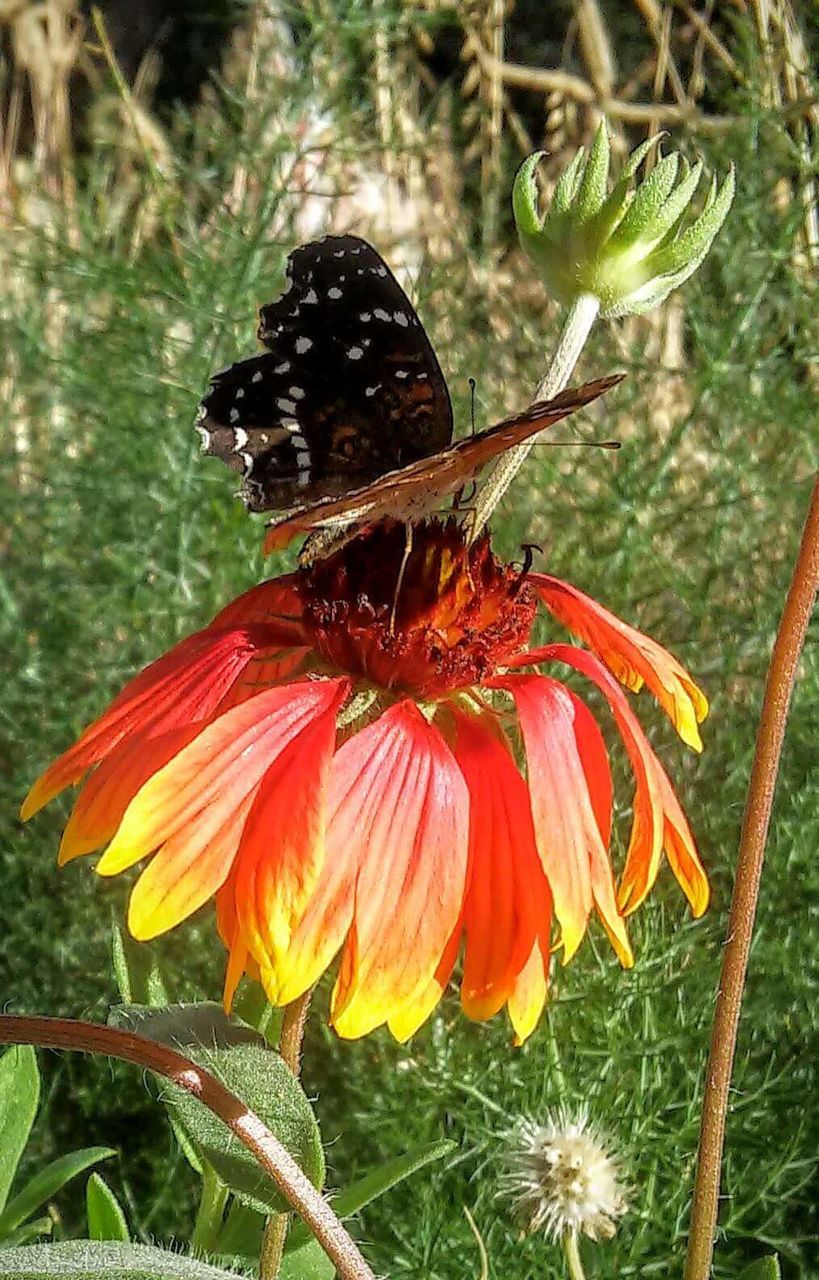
top-left (0, 0), bottom-right (819, 1280)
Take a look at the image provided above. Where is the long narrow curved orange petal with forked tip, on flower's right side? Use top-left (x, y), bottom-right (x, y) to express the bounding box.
top-left (537, 644), bottom-right (709, 916)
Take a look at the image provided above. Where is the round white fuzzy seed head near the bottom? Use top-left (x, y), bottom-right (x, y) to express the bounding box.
top-left (505, 1110), bottom-right (627, 1240)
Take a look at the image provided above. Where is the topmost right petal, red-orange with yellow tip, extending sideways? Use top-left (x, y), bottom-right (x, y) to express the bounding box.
top-left (534, 573), bottom-right (708, 751)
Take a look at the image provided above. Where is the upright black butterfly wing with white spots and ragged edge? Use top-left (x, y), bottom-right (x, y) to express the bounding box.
top-left (197, 236), bottom-right (452, 511)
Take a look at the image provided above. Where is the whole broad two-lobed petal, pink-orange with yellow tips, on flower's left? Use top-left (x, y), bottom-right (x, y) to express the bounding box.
top-left (97, 680), bottom-right (347, 938)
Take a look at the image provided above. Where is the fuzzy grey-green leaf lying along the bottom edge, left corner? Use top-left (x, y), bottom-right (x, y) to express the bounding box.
top-left (0, 1240), bottom-right (235, 1280)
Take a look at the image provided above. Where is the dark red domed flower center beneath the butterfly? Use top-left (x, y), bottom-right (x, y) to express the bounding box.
top-left (299, 520), bottom-right (536, 699)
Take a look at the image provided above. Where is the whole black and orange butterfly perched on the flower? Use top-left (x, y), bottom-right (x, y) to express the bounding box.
top-left (196, 236), bottom-right (621, 554)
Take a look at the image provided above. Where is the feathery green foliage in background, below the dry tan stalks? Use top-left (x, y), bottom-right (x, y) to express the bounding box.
top-left (0, 12), bottom-right (819, 1280)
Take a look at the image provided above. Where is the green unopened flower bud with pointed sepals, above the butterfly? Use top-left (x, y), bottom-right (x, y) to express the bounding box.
top-left (512, 120), bottom-right (735, 317)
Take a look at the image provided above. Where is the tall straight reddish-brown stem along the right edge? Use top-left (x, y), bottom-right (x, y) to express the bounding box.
top-left (685, 476), bottom-right (819, 1280)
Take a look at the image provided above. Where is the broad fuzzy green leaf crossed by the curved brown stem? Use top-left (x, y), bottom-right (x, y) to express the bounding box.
top-left (163, 1044), bottom-right (324, 1213)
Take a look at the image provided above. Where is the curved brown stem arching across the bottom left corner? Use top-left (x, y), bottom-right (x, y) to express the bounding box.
top-left (0, 1014), bottom-right (375, 1280)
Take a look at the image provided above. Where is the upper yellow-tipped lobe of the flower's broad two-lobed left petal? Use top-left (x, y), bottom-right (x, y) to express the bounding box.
top-left (97, 681), bottom-right (348, 876)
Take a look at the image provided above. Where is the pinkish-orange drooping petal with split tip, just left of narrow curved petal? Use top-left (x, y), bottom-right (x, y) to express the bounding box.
top-left (491, 676), bottom-right (633, 965)
